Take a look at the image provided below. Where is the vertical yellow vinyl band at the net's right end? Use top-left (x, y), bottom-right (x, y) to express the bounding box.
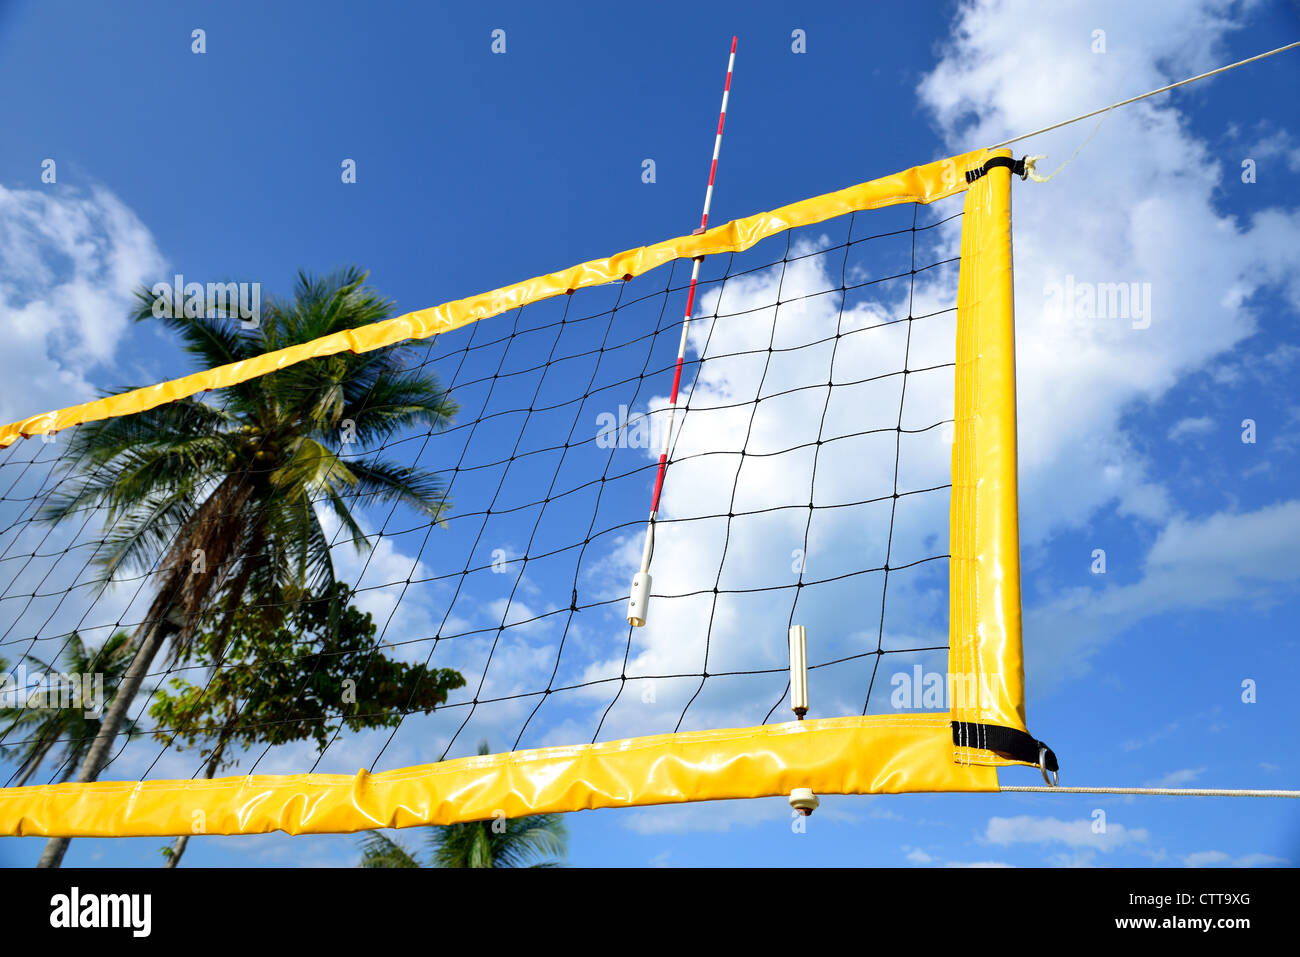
top-left (949, 150), bottom-right (1026, 765)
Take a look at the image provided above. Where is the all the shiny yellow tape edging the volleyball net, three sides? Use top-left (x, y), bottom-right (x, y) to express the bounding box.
top-left (0, 150), bottom-right (1024, 836)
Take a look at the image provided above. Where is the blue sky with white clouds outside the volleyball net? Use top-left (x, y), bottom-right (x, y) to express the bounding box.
top-left (0, 3), bottom-right (1300, 866)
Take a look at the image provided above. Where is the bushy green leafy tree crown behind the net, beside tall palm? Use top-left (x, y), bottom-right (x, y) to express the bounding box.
top-left (150, 583), bottom-right (465, 755)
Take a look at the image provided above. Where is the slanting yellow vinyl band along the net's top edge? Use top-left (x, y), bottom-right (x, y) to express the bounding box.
top-left (0, 150), bottom-right (987, 447)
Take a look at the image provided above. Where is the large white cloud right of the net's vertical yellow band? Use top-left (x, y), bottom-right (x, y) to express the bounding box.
top-left (919, 0), bottom-right (1300, 546)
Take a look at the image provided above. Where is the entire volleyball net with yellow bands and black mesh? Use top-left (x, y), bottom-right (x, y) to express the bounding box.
top-left (0, 150), bottom-right (1056, 836)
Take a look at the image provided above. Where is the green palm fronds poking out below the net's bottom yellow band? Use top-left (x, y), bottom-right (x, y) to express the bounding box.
top-left (359, 742), bottom-right (568, 867)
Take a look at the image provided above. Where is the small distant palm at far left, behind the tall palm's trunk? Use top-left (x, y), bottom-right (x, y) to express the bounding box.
top-left (0, 632), bottom-right (137, 788)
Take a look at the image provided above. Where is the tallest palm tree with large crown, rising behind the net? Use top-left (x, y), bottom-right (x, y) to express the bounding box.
top-left (39, 269), bottom-right (456, 867)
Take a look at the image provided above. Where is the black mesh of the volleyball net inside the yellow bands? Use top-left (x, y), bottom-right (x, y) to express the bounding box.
top-left (0, 196), bottom-right (961, 785)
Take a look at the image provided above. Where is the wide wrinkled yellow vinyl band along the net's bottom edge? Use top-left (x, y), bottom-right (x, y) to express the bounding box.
top-left (0, 714), bottom-right (997, 837)
